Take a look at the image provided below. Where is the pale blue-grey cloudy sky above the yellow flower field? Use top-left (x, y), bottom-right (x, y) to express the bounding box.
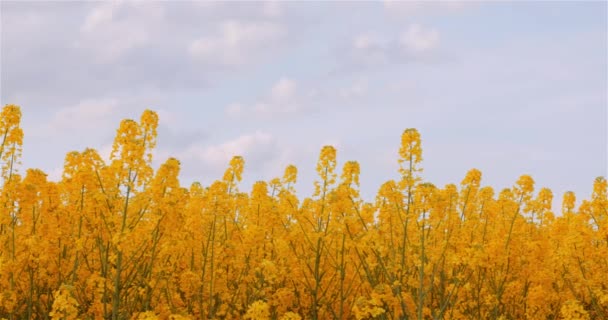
top-left (0, 1), bottom-right (608, 210)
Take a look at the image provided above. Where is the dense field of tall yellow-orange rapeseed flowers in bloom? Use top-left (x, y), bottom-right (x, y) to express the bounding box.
top-left (0, 105), bottom-right (608, 319)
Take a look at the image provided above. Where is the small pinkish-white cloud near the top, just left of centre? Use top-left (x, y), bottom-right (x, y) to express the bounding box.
top-left (189, 20), bottom-right (287, 66)
